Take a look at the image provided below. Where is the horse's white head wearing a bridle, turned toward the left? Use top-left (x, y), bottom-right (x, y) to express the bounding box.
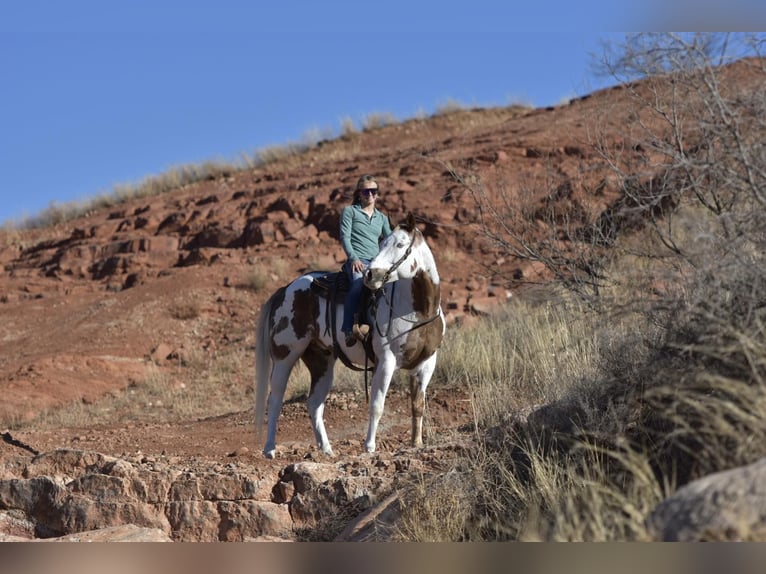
top-left (364, 213), bottom-right (439, 291)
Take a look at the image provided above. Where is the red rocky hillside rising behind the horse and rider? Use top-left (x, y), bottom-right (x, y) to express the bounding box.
top-left (0, 90), bottom-right (640, 420)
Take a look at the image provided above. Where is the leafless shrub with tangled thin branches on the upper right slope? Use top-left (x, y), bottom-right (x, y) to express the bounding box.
top-left (453, 34), bottom-right (766, 312)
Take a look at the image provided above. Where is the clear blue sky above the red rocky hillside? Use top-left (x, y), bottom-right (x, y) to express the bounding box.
top-left (0, 0), bottom-right (764, 224)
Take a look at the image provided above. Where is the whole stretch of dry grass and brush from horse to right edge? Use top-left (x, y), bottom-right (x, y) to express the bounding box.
top-left (398, 227), bottom-right (766, 541)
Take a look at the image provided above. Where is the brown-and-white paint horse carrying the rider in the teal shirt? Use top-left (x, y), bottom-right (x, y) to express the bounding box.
top-left (255, 213), bottom-right (446, 458)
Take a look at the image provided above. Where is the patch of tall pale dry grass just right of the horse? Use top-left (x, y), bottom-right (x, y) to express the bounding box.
top-left (434, 299), bottom-right (617, 426)
